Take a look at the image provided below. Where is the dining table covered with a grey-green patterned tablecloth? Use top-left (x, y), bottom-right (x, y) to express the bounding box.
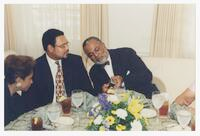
top-left (4, 91), bottom-right (191, 131)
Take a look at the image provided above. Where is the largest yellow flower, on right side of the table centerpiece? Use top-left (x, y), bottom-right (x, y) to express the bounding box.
top-left (128, 98), bottom-right (144, 119)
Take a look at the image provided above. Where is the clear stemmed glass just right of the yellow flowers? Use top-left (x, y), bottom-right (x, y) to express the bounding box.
top-left (152, 91), bottom-right (165, 123)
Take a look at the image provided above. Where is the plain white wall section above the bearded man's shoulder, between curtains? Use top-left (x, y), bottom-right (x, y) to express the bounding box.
top-left (108, 4), bottom-right (155, 56)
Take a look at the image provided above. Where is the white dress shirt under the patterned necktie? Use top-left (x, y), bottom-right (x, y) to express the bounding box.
top-left (46, 53), bottom-right (66, 103)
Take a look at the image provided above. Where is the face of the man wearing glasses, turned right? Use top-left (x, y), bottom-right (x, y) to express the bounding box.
top-left (47, 35), bottom-right (69, 60)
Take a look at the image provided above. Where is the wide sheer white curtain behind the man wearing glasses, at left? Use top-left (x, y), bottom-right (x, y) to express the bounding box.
top-left (5, 4), bottom-right (81, 58)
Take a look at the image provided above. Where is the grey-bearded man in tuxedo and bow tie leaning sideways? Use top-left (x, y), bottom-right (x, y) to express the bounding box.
top-left (83, 37), bottom-right (158, 98)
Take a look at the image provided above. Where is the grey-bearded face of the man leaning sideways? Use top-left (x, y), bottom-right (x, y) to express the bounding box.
top-left (83, 39), bottom-right (108, 64)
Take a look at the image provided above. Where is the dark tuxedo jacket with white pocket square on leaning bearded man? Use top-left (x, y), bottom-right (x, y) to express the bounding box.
top-left (89, 48), bottom-right (158, 98)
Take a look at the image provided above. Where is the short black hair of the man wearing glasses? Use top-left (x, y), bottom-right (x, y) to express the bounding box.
top-left (42, 29), bottom-right (64, 51)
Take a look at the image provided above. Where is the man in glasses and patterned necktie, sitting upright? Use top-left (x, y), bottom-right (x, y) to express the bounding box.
top-left (25, 29), bottom-right (93, 108)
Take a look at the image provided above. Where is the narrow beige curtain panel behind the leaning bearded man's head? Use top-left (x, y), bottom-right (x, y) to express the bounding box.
top-left (80, 4), bottom-right (109, 71)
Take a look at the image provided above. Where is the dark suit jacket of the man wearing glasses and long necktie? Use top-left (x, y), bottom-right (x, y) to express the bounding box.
top-left (24, 54), bottom-right (93, 108)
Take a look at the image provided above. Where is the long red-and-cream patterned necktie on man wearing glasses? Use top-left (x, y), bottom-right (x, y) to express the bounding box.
top-left (55, 61), bottom-right (65, 102)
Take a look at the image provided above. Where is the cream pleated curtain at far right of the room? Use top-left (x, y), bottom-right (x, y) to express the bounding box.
top-left (150, 4), bottom-right (196, 58)
